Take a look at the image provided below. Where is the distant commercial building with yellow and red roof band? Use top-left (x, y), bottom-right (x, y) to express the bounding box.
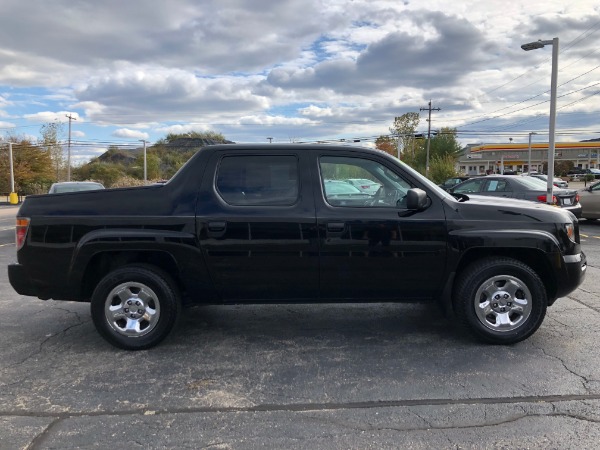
top-left (458, 141), bottom-right (600, 175)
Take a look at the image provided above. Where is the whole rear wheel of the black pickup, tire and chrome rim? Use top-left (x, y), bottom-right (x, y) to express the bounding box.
top-left (91, 265), bottom-right (181, 350)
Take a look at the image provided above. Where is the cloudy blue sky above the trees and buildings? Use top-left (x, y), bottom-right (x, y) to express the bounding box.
top-left (0, 0), bottom-right (600, 164)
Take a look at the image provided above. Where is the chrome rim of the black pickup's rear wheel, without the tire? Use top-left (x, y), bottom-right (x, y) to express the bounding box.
top-left (104, 281), bottom-right (160, 337)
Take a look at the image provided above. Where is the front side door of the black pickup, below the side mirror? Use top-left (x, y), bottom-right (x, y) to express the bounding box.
top-left (315, 152), bottom-right (446, 301)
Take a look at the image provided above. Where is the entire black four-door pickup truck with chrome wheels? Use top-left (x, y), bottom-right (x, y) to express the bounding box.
top-left (8, 144), bottom-right (586, 350)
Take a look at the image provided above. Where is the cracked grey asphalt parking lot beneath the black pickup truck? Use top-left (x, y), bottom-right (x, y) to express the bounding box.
top-left (0, 205), bottom-right (600, 449)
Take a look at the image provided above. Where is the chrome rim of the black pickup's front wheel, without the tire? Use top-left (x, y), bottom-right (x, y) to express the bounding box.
top-left (474, 275), bottom-right (532, 333)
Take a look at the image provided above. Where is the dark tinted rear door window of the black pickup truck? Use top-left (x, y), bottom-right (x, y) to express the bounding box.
top-left (216, 155), bottom-right (299, 206)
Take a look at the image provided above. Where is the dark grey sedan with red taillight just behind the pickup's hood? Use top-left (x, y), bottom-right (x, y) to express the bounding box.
top-left (448, 175), bottom-right (582, 217)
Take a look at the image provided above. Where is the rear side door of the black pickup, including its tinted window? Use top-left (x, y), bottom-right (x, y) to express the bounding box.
top-left (196, 150), bottom-right (318, 302)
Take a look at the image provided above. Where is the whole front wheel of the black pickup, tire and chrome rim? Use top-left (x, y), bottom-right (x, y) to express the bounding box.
top-left (453, 257), bottom-right (548, 344)
